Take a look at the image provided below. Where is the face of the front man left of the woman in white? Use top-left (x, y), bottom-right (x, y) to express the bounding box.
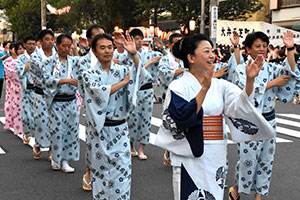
top-left (94, 38), bottom-right (114, 63)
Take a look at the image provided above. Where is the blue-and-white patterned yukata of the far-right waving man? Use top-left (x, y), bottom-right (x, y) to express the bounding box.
top-left (234, 58), bottom-right (300, 195)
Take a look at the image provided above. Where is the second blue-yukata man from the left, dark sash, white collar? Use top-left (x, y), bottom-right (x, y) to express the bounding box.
top-left (29, 29), bottom-right (55, 161)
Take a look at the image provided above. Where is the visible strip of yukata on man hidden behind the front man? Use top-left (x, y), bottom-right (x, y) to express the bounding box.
top-left (76, 49), bottom-right (98, 169)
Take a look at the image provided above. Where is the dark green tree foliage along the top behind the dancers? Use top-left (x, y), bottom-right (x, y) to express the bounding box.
top-left (0, 0), bottom-right (263, 38)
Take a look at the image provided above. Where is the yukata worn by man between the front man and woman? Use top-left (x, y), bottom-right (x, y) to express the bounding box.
top-left (123, 49), bottom-right (162, 144)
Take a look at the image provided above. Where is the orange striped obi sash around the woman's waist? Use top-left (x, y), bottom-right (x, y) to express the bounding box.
top-left (203, 115), bottom-right (224, 140)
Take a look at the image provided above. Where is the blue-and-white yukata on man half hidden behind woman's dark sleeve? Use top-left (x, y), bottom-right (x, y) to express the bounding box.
top-left (158, 51), bottom-right (184, 101)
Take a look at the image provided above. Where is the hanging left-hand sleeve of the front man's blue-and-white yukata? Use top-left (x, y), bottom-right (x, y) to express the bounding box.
top-left (82, 70), bottom-right (111, 133)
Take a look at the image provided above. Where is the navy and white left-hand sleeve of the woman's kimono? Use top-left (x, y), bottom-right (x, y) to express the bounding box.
top-left (155, 80), bottom-right (204, 158)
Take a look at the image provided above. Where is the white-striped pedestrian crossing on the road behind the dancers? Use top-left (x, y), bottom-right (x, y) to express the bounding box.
top-left (0, 114), bottom-right (300, 154)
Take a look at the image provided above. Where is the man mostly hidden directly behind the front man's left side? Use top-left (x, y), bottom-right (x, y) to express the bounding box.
top-left (77, 24), bottom-right (105, 191)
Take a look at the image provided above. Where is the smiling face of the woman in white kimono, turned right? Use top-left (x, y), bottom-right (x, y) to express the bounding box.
top-left (188, 40), bottom-right (215, 73)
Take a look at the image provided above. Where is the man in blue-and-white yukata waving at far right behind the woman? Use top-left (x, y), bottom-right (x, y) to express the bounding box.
top-left (229, 31), bottom-right (300, 200)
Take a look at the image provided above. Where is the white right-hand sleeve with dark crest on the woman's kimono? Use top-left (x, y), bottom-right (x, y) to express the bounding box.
top-left (222, 81), bottom-right (275, 142)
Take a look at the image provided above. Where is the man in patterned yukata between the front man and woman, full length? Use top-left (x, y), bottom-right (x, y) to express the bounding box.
top-left (124, 29), bottom-right (166, 160)
